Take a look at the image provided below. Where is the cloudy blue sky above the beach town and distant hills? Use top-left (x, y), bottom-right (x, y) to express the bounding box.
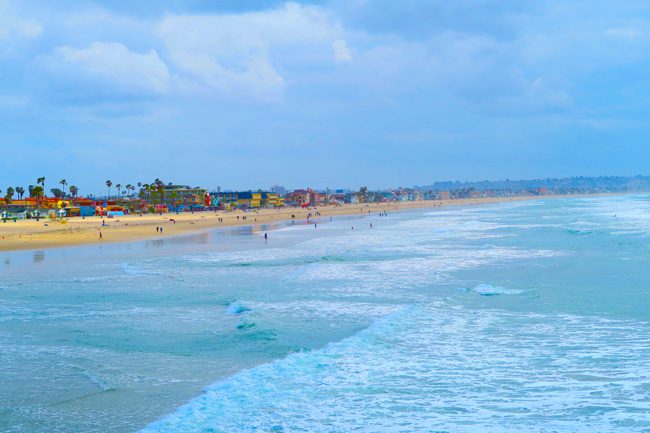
top-left (0, 0), bottom-right (650, 194)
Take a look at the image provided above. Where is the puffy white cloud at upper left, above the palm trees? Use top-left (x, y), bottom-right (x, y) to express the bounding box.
top-left (38, 42), bottom-right (171, 99)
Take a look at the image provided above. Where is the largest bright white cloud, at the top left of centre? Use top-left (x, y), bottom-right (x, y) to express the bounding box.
top-left (157, 3), bottom-right (349, 100)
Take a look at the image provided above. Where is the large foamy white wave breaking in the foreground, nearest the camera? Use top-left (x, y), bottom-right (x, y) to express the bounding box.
top-left (142, 303), bottom-right (650, 433)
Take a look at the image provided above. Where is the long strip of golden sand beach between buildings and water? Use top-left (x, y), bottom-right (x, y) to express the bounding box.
top-left (0, 194), bottom-right (609, 252)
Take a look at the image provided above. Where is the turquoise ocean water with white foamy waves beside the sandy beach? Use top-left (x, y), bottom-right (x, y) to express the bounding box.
top-left (0, 196), bottom-right (650, 433)
